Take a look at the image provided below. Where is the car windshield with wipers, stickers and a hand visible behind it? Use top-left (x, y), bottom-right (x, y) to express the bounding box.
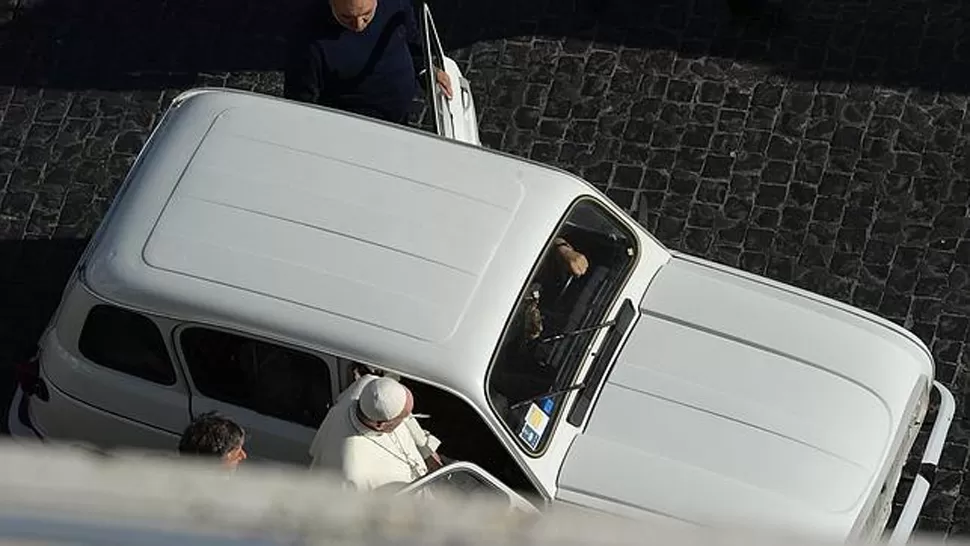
top-left (488, 200), bottom-right (637, 453)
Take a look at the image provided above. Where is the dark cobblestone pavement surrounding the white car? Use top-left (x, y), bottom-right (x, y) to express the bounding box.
top-left (0, 0), bottom-right (970, 534)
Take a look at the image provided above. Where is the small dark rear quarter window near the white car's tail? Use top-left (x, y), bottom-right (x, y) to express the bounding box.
top-left (78, 305), bottom-right (175, 385)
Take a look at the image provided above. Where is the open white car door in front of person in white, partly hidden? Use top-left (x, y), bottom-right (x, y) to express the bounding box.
top-left (398, 462), bottom-right (539, 515)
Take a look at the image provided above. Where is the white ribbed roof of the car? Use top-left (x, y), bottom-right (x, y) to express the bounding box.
top-left (85, 89), bottom-right (594, 396)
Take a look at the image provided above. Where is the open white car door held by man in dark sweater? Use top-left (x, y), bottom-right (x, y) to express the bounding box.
top-left (421, 2), bottom-right (481, 146)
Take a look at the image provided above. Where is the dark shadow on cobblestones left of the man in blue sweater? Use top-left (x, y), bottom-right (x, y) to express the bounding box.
top-left (0, 0), bottom-right (306, 90)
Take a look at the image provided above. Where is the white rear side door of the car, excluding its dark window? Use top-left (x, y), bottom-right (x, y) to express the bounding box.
top-left (172, 323), bottom-right (340, 465)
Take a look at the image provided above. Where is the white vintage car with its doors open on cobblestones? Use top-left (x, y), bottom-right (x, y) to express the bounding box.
top-left (10, 79), bottom-right (953, 541)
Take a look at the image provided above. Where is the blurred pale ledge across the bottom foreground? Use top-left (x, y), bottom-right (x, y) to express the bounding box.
top-left (0, 443), bottom-right (952, 546)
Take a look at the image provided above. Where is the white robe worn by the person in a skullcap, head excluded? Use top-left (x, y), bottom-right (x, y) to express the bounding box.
top-left (310, 375), bottom-right (441, 490)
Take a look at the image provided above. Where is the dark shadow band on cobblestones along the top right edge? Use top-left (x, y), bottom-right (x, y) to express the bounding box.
top-left (431, 0), bottom-right (970, 92)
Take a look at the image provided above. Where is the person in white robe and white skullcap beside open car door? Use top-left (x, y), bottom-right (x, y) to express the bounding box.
top-left (310, 375), bottom-right (441, 491)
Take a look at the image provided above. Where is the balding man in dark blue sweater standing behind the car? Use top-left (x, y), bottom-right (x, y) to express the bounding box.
top-left (283, 0), bottom-right (451, 124)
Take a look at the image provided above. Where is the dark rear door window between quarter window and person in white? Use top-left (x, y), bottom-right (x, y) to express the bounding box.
top-left (179, 327), bottom-right (332, 428)
